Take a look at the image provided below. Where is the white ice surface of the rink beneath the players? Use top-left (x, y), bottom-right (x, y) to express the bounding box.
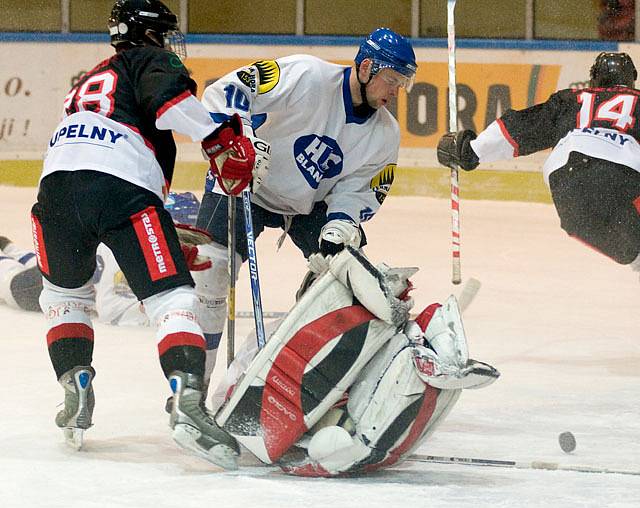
top-left (0, 187), bottom-right (640, 508)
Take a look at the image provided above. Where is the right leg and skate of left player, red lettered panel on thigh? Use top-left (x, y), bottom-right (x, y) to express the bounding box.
top-left (101, 182), bottom-right (239, 468)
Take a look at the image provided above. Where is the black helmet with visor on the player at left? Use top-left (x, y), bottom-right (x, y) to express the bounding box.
top-left (109, 0), bottom-right (186, 58)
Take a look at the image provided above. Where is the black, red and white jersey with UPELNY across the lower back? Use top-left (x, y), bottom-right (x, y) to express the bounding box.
top-left (41, 46), bottom-right (214, 198)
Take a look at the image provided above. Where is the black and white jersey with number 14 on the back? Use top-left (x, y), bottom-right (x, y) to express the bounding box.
top-left (471, 86), bottom-right (640, 182)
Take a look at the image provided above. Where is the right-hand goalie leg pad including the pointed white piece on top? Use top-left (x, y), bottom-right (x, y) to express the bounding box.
top-left (280, 296), bottom-right (499, 477)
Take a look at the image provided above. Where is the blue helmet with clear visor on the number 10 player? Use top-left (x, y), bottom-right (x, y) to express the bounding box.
top-left (355, 28), bottom-right (418, 88)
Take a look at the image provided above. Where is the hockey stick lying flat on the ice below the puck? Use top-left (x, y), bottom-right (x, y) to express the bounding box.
top-left (407, 454), bottom-right (640, 476)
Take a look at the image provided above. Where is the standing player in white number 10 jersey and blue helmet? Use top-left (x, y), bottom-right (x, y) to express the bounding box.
top-left (196, 28), bottom-right (417, 388)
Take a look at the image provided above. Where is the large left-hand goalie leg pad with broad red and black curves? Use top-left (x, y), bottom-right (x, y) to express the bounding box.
top-left (216, 272), bottom-right (396, 463)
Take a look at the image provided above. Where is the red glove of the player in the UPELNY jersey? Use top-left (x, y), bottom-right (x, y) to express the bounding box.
top-left (202, 114), bottom-right (256, 196)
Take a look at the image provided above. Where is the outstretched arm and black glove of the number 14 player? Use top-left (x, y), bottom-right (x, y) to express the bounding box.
top-left (438, 92), bottom-right (567, 171)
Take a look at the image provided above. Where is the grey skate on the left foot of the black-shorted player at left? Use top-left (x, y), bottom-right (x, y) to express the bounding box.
top-left (56, 367), bottom-right (96, 450)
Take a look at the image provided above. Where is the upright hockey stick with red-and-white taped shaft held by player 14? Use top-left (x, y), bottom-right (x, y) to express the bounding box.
top-left (447, 0), bottom-right (462, 284)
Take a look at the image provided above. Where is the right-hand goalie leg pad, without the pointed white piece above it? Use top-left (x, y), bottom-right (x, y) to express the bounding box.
top-left (281, 334), bottom-right (460, 476)
